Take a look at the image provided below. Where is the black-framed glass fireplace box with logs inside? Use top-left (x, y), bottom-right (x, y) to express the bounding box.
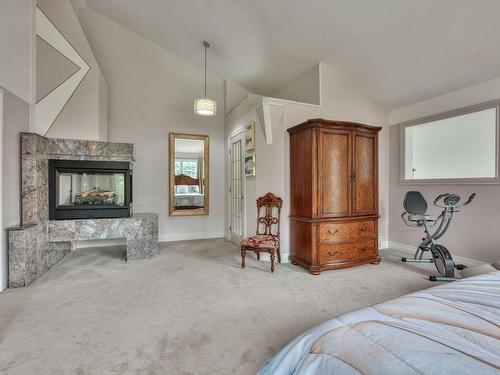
top-left (48, 159), bottom-right (132, 220)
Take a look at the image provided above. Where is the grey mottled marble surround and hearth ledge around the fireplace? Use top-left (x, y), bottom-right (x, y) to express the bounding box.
top-left (7, 133), bottom-right (159, 288)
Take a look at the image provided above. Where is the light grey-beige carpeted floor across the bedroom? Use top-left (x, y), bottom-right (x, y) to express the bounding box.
top-left (0, 239), bottom-right (434, 375)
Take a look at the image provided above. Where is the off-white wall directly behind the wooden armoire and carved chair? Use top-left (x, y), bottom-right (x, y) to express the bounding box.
top-left (225, 64), bottom-right (388, 262)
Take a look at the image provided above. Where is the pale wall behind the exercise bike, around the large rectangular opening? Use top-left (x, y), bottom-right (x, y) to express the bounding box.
top-left (389, 78), bottom-right (500, 262)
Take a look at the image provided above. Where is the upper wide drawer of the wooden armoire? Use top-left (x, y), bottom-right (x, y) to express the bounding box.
top-left (319, 220), bottom-right (375, 242)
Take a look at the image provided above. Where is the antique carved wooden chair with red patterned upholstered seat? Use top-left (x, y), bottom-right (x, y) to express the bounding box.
top-left (241, 193), bottom-right (283, 272)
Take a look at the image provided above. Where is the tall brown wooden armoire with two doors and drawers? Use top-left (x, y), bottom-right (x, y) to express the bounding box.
top-left (288, 119), bottom-right (381, 275)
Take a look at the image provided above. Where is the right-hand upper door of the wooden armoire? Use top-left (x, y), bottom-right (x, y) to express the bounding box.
top-left (352, 132), bottom-right (378, 215)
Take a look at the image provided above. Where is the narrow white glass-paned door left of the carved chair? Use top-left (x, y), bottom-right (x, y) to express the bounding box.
top-left (229, 133), bottom-right (245, 246)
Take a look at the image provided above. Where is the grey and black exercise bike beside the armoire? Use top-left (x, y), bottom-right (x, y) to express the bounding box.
top-left (401, 191), bottom-right (476, 281)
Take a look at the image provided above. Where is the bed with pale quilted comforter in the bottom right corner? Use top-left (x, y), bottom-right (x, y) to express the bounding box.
top-left (258, 272), bottom-right (500, 375)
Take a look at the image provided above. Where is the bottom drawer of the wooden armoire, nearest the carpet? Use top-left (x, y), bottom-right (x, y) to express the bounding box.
top-left (319, 239), bottom-right (376, 263)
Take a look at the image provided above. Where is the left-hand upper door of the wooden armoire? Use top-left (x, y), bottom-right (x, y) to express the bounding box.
top-left (318, 129), bottom-right (352, 217)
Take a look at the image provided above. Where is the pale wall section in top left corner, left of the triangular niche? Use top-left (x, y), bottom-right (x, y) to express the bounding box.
top-left (0, 0), bottom-right (33, 103)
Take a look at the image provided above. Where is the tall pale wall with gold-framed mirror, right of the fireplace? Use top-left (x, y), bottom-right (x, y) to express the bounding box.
top-left (79, 9), bottom-right (225, 241)
